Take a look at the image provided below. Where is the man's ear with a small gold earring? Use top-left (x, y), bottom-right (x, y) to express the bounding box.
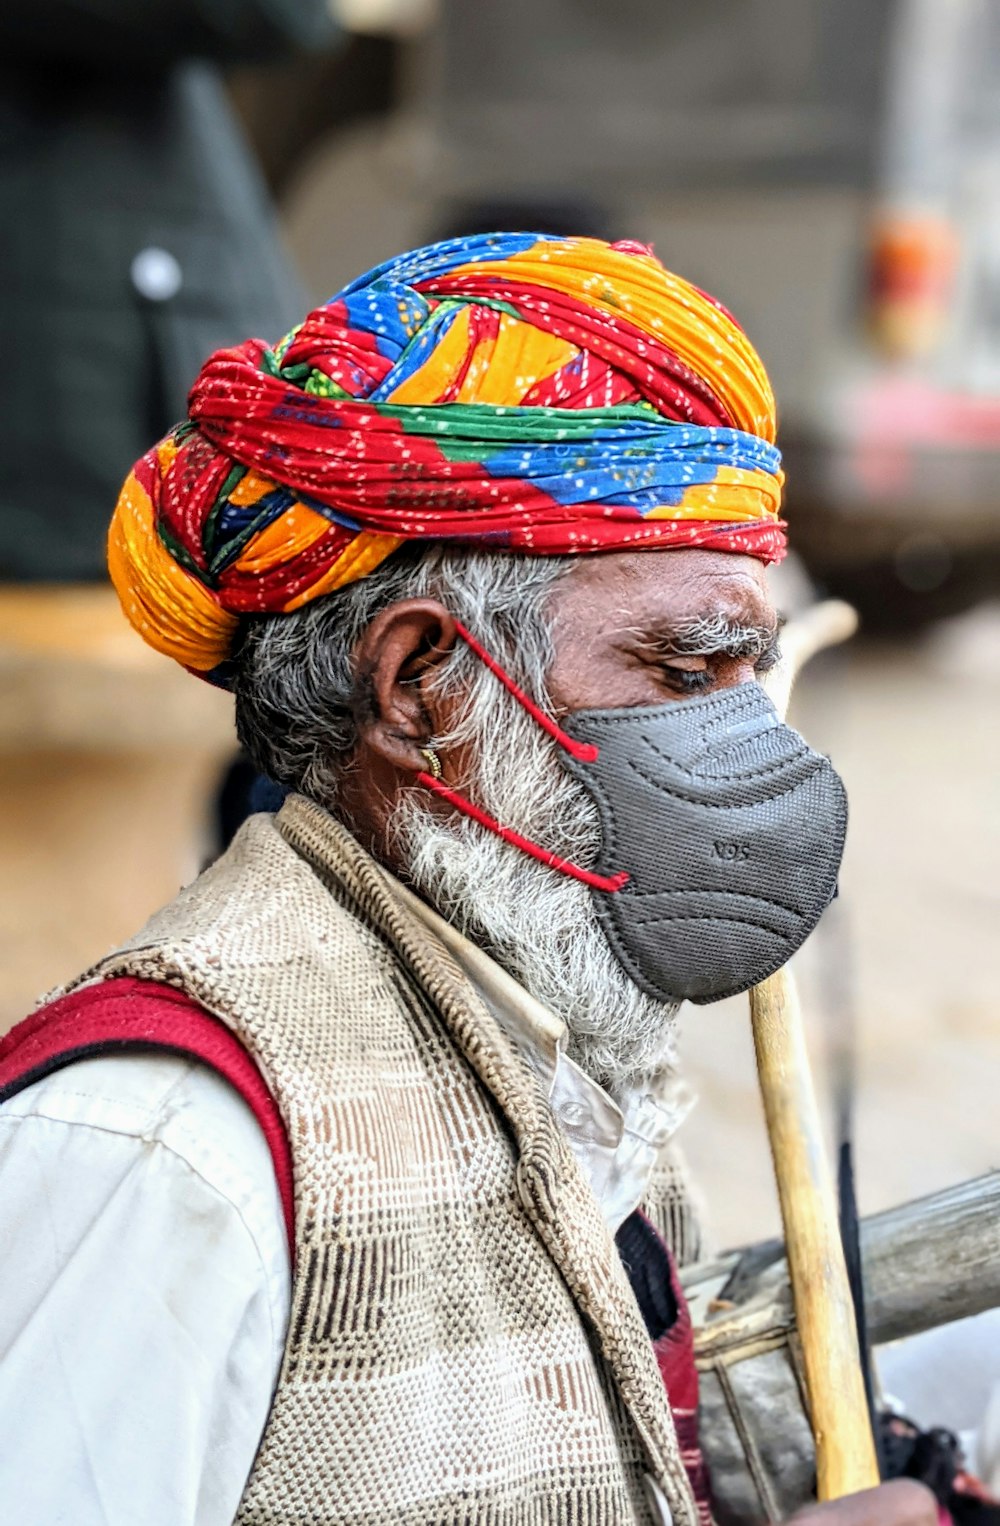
top-left (354, 598), bottom-right (456, 772)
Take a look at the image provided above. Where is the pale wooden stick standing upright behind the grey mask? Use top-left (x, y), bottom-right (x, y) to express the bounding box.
top-left (750, 601), bottom-right (879, 1500)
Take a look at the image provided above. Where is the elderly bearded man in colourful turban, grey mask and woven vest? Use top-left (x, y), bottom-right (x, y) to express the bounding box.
top-left (0, 235), bottom-right (936, 1526)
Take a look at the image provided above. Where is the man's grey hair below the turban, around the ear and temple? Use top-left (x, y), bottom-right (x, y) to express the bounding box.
top-left (234, 543), bottom-right (571, 807)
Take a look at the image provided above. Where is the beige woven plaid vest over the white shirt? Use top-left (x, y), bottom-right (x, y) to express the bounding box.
top-left (76, 797), bottom-right (696, 1526)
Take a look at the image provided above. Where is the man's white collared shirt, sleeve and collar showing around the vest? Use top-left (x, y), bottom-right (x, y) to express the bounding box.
top-left (0, 909), bottom-right (690, 1526)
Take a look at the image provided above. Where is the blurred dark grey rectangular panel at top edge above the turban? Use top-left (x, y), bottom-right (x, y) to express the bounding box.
top-left (440, 0), bottom-right (890, 195)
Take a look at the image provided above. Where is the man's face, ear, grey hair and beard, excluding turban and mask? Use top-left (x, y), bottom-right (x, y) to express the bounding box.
top-left (234, 548), bottom-right (777, 1087)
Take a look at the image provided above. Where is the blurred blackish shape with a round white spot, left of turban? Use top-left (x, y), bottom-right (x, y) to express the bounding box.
top-left (0, 0), bottom-right (333, 581)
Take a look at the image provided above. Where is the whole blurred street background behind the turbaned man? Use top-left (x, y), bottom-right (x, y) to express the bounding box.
top-left (0, 0), bottom-right (1000, 1361)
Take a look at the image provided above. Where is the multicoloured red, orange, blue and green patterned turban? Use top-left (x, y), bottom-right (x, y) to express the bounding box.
top-left (108, 233), bottom-right (785, 673)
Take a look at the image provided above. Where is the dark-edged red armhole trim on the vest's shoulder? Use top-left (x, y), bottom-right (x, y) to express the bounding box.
top-left (0, 977), bottom-right (295, 1259)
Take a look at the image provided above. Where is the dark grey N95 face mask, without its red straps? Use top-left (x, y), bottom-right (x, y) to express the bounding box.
top-left (562, 684), bottom-right (847, 1003)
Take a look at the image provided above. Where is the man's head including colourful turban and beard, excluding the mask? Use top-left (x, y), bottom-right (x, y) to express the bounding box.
top-left (108, 233), bottom-right (800, 1098)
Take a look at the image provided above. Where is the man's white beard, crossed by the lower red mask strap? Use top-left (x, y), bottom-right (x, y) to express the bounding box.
top-left (391, 691), bottom-right (679, 1096)
